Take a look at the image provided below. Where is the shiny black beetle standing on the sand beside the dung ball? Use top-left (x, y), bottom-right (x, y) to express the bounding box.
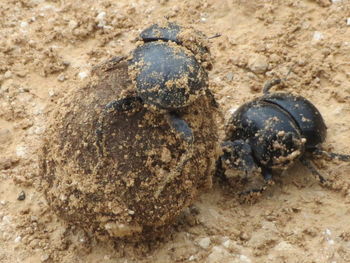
top-left (217, 79), bottom-right (350, 194)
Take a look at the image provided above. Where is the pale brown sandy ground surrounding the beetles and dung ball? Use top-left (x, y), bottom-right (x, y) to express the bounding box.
top-left (0, 0), bottom-right (350, 263)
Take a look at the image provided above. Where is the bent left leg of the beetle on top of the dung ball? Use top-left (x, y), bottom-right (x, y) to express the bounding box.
top-left (95, 97), bottom-right (142, 155)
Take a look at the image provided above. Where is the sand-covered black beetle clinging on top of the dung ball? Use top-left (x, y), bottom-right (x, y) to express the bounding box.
top-left (96, 22), bottom-right (217, 144)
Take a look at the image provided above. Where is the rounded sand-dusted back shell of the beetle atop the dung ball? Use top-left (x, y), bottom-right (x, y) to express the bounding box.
top-left (130, 41), bottom-right (208, 109)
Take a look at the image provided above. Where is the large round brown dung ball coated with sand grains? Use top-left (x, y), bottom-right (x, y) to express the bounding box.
top-left (40, 58), bottom-right (217, 238)
